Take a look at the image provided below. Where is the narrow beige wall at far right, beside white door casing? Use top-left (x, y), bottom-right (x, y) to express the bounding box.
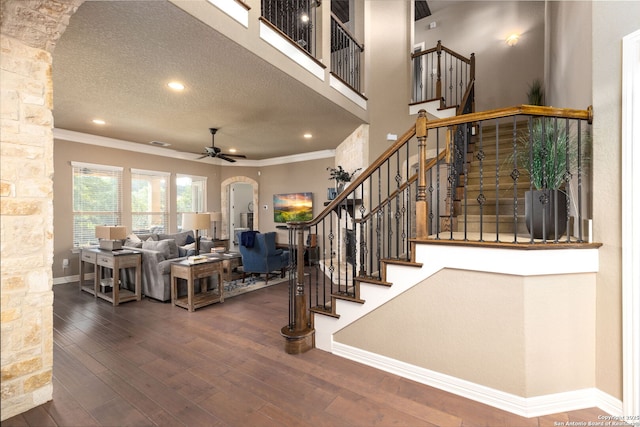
top-left (586, 1), bottom-right (640, 399)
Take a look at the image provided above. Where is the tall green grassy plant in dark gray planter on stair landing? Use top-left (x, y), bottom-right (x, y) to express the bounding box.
top-left (512, 117), bottom-right (585, 239)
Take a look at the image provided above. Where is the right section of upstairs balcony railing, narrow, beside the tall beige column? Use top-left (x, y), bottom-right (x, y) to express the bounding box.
top-left (331, 13), bottom-right (364, 93)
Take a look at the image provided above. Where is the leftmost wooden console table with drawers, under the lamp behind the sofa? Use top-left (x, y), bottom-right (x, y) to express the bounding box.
top-left (79, 248), bottom-right (142, 306)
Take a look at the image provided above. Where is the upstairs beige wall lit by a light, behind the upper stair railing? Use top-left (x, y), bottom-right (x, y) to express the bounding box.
top-left (414, 1), bottom-right (544, 111)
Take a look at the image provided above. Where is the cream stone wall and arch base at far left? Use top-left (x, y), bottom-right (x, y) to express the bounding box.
top-left (0, 0), bottom-right (83, 420)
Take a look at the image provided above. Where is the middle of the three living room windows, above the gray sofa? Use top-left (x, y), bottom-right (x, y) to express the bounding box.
top-left (131, 169), bottom-right (170, 233)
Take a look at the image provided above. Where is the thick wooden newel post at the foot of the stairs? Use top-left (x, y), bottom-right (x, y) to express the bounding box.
top-left (280, 226), bottom-right (314, 354)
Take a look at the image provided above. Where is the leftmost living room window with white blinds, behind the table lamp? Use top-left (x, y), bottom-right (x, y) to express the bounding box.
top-left (71, 162), bottom-right (122, 248)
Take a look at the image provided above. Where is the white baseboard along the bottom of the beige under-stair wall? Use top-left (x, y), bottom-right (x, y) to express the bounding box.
top-left (332, 341), bottom-right (622, 421)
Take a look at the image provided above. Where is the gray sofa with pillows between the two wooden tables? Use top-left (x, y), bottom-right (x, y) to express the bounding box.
top-left (124, 231), bottom-right (213, 301)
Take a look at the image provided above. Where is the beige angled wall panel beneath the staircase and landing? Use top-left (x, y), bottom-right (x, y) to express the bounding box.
top-left (334, 270), bottom-right (595, 397)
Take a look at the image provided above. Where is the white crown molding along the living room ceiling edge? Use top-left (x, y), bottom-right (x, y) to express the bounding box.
top-left (53, 128), bottom-right (336, 168)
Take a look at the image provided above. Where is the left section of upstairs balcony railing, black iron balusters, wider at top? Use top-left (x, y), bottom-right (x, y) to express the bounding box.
top-left (262, 0), bottom-right (317, 57)
